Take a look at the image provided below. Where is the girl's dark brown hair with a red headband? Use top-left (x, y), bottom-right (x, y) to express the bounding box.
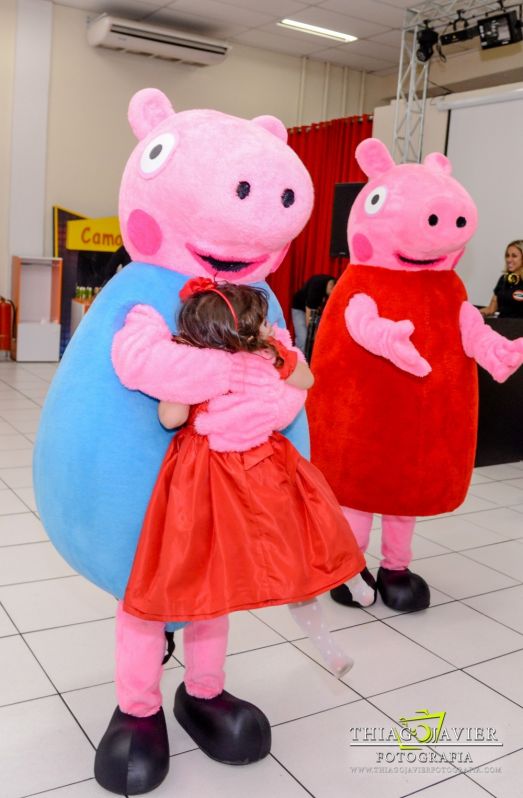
top-left (173, 283), bottom-right (283, 367)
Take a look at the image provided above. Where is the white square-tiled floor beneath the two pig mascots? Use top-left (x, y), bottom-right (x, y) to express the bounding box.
top-left (0, 362), bottom-right (523, 798)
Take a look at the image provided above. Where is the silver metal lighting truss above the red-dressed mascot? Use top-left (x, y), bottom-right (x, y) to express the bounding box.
top-left (392, 0), bottom-right (519, 163)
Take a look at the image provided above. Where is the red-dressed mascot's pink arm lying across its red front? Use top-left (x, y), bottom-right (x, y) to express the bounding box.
top-left (345, 294), bottom-right (432, 377)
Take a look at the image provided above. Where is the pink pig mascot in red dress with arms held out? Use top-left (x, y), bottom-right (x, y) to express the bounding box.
top-left (307, 139), bottom-right (523, 611)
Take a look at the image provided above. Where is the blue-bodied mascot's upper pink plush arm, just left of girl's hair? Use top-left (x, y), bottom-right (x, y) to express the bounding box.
top-left (111, 305), bottom-right (233, 404)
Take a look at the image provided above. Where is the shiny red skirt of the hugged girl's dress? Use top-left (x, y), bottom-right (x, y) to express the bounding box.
top-left (124, 406), bottom-right (365, 621)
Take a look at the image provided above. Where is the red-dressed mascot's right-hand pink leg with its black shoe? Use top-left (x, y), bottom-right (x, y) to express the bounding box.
top-left (377, 515), bottom-right (430, 612)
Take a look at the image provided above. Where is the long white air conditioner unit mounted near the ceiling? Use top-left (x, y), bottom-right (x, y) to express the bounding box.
top-left (87, 14), bottom-right (230, 66)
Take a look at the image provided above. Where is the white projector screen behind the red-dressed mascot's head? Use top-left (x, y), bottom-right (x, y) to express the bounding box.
top-left (447, 98), bottom-right (523, 305)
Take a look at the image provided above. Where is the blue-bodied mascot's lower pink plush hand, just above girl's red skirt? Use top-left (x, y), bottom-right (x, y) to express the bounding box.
top-left (195, 352), bottom-right (307, 452)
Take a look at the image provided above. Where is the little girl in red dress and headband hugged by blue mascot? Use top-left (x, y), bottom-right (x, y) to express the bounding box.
top-left (124, 278), bottom-right (374, 676)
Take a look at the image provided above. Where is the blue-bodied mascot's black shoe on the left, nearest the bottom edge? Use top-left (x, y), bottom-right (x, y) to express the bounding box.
top-left (94, 707), bottom-right (169, 795)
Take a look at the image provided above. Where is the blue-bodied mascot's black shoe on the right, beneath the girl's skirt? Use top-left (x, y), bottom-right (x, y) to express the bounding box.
top-left (174, 682), bottom-right (271, 765)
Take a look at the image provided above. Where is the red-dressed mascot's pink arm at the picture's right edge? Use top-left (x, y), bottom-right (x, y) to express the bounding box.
top-left (459, 302), bottom-right (523, 382)
